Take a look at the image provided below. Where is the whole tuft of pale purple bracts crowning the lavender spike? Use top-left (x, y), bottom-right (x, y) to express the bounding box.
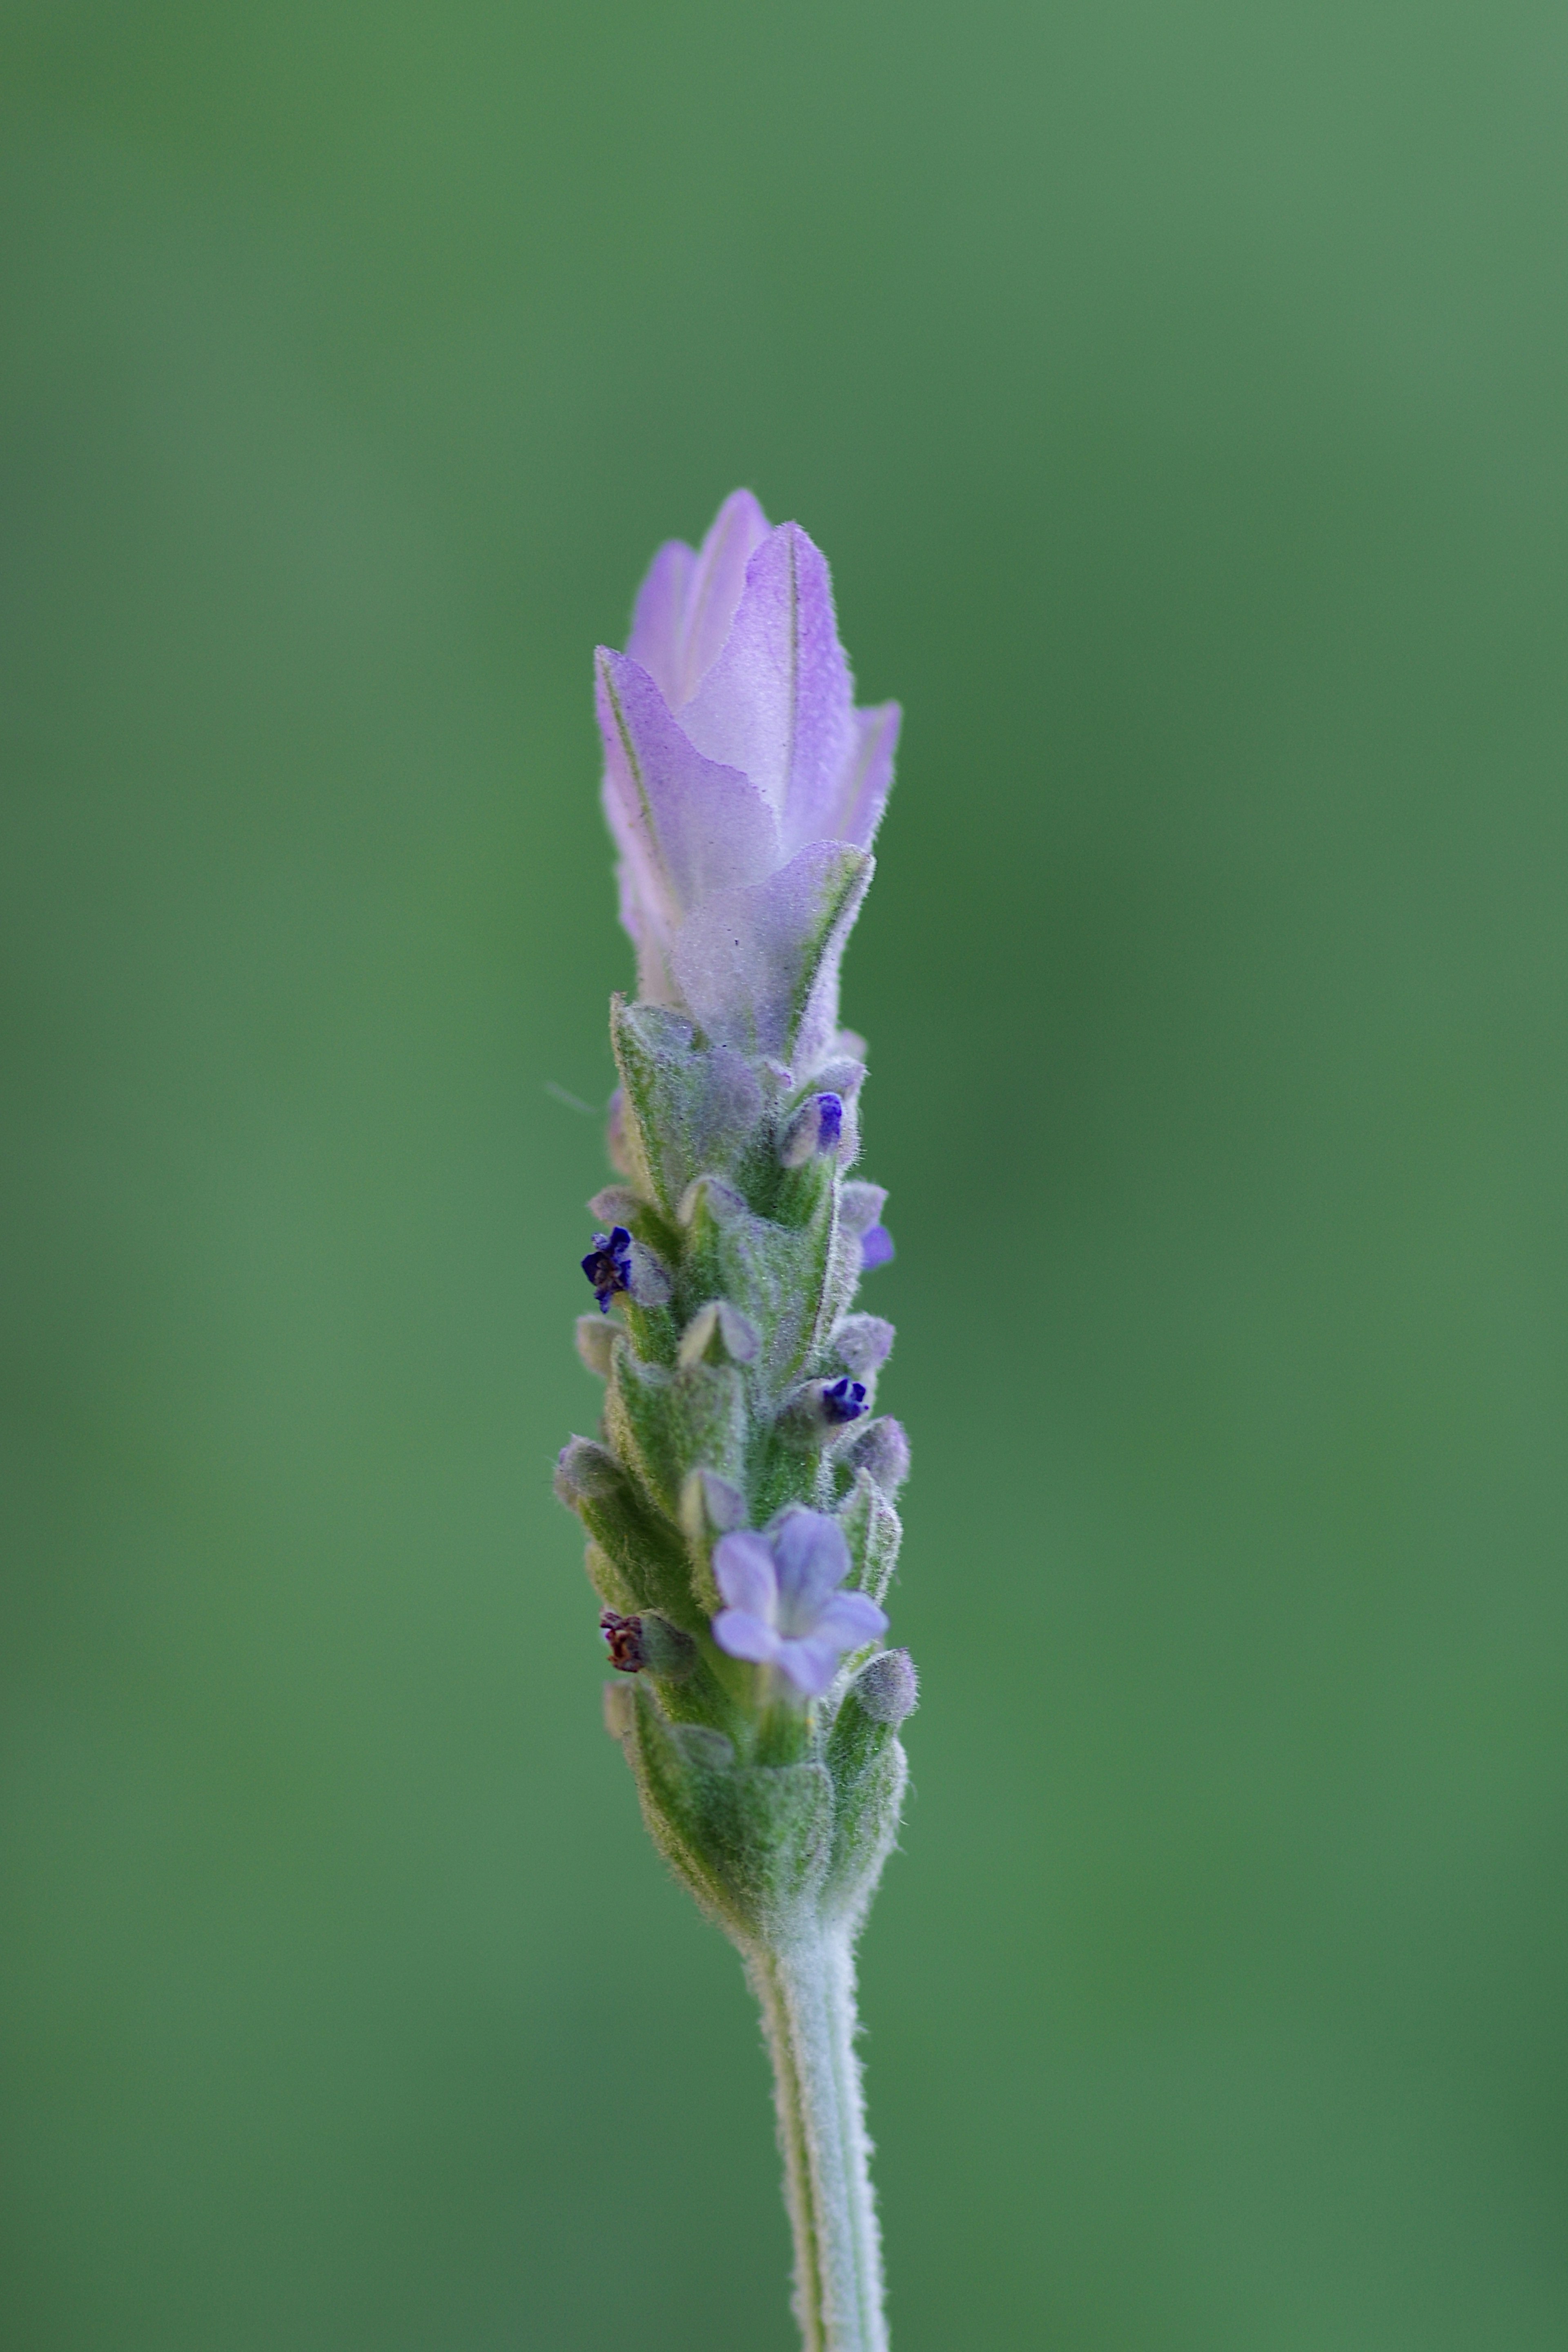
top-left (597, 489), bottom-right (898, 1070)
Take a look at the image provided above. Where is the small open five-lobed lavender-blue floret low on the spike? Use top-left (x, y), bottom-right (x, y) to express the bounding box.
top-left (712, 1505), bottom-right (889, 1698)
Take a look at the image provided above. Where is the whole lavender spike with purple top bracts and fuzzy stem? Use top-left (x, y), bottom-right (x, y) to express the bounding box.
top-left (555, 492), bottom-right (915, 2352)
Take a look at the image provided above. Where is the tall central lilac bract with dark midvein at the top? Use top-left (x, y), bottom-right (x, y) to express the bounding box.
top-left (682, 522), bottom-right (856, 856)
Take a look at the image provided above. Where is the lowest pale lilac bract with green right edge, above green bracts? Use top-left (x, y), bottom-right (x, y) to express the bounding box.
top-left (670, 842), bottom-right (872, 1068)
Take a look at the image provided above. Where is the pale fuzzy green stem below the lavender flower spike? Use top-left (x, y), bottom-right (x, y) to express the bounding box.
top-left (748, 1922), bottom-right (889, 2352)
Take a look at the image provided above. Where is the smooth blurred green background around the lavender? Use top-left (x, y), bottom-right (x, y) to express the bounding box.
top-left (0, 0), bottom-right (1568, 2352)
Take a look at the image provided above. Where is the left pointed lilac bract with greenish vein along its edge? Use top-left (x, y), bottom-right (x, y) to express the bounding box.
top-left (597, 647), bottom-right (778, 922)
